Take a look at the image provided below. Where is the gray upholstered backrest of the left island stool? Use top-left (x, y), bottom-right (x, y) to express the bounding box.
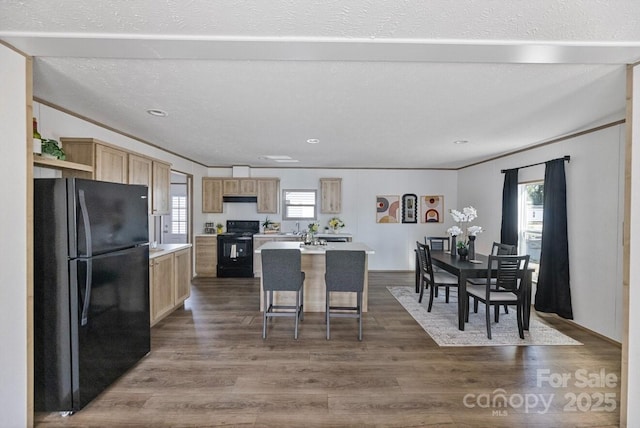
top-left (260, 249), bottom-right (302, 291)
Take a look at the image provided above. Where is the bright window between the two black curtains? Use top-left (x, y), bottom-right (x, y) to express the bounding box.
top-left (518, 181), bottom-right (544, 281)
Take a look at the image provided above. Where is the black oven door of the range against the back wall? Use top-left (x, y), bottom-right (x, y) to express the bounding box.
top-left (218, 236), bottom-right (253, 277)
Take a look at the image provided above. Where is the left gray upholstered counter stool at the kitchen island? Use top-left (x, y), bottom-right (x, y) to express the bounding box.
top-left (260, 249), bottom-right (305, 339)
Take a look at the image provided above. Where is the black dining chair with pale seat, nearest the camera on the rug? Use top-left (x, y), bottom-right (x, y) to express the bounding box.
top-left (465, 254), bottom-right (529, 339)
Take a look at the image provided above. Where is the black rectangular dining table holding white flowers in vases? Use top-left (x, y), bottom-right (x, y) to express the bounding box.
top-left (431, 251), bottom-right (533, 330)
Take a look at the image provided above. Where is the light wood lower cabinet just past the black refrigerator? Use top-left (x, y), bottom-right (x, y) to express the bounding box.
top-left (149, 248), bottom-right (191, 325)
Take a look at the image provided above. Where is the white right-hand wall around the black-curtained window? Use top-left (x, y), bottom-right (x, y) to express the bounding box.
top-left (458, 125), bottom-right (625, 341)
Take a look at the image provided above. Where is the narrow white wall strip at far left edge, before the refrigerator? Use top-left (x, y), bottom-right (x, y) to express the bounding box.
top-left (0, 45), bottom-right (29, 427)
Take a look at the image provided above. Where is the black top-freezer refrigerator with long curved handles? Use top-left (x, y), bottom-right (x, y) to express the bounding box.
top-left (34, 178), bottom-right (150, 412)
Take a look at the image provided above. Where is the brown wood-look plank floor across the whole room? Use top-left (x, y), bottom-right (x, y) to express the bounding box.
top-left (35, 272), bottom-right (620, 428)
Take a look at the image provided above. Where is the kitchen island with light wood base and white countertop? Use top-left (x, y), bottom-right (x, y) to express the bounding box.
top-left (255, 241), bottom-right (375, 312)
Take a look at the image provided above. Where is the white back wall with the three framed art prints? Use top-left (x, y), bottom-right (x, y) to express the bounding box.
top-left (201, 168), bottom-right (457, 270)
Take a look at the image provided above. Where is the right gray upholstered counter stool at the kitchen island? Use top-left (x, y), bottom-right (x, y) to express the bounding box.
top-left (324, 250), bottom-right (366, 340)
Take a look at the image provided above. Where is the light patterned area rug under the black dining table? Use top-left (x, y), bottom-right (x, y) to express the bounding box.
top-left (387, 286), bottom-right (582, 346)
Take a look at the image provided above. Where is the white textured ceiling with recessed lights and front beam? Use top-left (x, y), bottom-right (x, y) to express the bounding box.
top-left (0, 0), bottom-right (640, 168)
